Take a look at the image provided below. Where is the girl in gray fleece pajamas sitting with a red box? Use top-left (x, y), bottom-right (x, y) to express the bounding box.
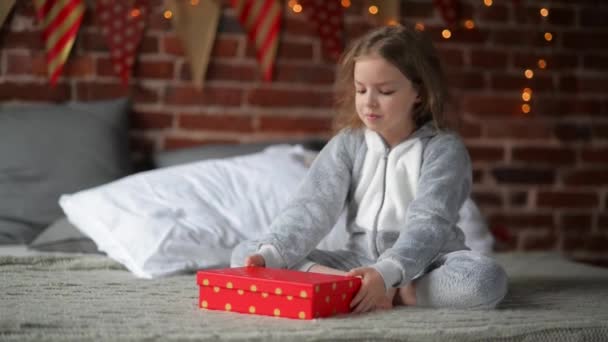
top-left (232, 26), bottom-right (507, 312)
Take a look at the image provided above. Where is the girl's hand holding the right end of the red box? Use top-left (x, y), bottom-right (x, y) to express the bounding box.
top-left (346, 267), bottom-right (386, 313)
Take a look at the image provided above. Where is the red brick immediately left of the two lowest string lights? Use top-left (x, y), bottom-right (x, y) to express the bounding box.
top-left (462, 94), bottom-right (520, 117)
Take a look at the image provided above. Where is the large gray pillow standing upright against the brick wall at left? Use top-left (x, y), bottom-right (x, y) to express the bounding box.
top-left (0, 98), bottom-right (132, 244)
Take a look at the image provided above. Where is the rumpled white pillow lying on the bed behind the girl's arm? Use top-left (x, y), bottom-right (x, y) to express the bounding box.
top-left (59, 145), bottom-right (318, 278)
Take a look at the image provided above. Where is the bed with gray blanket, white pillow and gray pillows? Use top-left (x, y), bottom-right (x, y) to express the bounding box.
top-left (0, 99), bottom-right (608, 341)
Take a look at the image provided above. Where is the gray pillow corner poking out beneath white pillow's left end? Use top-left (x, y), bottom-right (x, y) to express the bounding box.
top-left (28, 216), bottom-right (101, 253)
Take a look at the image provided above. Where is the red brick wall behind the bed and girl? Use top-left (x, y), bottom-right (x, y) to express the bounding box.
top-left (0, 0), bottom-right (608, 261)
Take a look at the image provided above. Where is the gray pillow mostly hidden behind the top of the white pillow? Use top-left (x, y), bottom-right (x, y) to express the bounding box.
top-left (154, 138), bottom-right (326, 167)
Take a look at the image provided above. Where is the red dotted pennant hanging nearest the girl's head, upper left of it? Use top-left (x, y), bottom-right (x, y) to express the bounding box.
top-left (300, 0), bottom-right (344, 60)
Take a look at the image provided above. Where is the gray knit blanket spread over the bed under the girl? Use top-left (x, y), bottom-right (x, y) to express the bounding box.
top-left (0, 253), bottom-right (608, 342)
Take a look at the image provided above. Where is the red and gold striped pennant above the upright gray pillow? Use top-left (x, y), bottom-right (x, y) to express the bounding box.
top-left (34, 0), bottom-right (85, 85)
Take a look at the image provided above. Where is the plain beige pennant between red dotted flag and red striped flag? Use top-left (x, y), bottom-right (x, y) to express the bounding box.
top-left (165, 0), bottom-right (221, 89)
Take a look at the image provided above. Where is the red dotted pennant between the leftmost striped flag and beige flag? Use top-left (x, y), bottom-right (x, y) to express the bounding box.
top-left (96, 0), bottom-right (148, 86)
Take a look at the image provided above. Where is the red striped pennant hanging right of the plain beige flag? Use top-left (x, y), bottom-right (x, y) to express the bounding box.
top-left (231, 0), bottom-right (283, 81)
